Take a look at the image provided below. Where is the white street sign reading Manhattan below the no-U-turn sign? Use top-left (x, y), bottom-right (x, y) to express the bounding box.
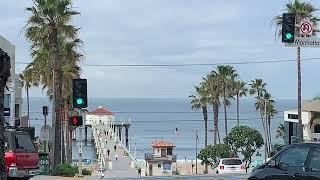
top-left (285, 37), bottom-right (320, 48)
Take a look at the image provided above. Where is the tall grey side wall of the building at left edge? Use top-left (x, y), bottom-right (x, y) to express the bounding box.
top-left (0, 35), bottom-right (15, 126)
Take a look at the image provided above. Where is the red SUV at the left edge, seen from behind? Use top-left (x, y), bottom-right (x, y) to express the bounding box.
top-left (5, 128), bottom-right (39, 180)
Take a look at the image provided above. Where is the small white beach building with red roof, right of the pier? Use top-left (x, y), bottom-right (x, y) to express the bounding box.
top-left (145, 140), bottom-right (177, 176)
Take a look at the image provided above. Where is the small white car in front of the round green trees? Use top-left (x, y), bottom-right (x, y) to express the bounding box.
top-left (216, 158), bottom-right (245, 174)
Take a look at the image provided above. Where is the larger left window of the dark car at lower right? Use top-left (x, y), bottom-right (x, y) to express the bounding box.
top-left (276, 147), bottom-right (310, 167)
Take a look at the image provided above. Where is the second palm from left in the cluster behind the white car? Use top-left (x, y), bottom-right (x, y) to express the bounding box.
top-left (202, 71), bottom-right (220, 144)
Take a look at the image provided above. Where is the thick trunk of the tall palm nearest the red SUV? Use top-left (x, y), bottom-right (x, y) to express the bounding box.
top-left (49, 27), bottom-right (62, 167)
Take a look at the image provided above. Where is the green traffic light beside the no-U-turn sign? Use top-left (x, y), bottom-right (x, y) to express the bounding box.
top-left (282, 13), bottom-right (296, 43)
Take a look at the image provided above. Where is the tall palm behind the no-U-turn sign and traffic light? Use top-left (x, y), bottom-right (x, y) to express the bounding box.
top-left (273, 0), bottom-right (319, 141)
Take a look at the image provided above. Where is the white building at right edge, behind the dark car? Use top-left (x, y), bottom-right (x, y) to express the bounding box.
top-left (284, 101), bottom-right (320, 144)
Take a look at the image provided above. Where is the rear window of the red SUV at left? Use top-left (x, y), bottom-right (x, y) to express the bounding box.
top-left (14, 134), bottom-right (36, 152)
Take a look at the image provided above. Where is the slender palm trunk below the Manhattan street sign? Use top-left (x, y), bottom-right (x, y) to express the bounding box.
top-left (297, 47), bottom-right (303, 142)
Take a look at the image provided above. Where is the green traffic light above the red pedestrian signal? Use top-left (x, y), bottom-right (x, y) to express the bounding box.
top-left (72, 79), bottom-right (88, 109)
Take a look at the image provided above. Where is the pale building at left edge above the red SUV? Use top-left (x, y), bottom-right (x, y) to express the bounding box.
top-left (0, 35), bottom-right (23, 126)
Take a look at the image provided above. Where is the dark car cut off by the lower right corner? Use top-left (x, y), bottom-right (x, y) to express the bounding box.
top-left (248, 143), bottom-right (320, 180)
